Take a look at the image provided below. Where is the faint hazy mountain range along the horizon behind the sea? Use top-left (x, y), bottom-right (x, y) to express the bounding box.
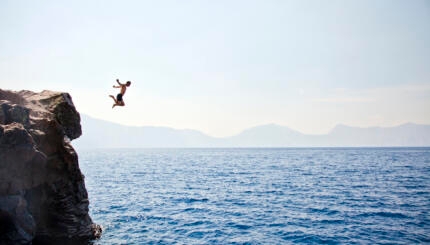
top-left (72, 115), bottom-right (430, 148)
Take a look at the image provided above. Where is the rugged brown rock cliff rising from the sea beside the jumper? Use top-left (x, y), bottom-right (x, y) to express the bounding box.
top-left (0, 89), bottom-right (101, 244)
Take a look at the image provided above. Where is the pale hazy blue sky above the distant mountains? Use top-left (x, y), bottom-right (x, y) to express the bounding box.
top-left (0, 0), bottom-right (430, 137)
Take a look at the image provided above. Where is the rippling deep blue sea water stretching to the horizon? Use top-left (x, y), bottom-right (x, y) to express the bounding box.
top-left (79, 148), bottom-right (430, 244)
